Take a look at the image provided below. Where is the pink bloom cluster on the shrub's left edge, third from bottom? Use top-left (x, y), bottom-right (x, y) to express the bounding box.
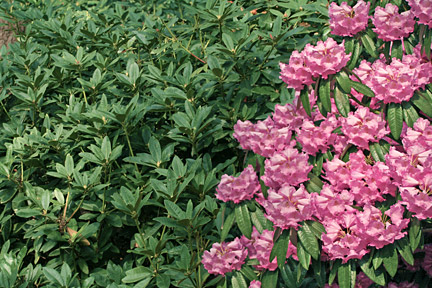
top-left (233, 117), bottom-right (291, 157)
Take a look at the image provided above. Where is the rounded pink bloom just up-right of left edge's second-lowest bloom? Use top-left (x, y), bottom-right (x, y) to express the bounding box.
top-left (261, 141), bottom-right (312, 189)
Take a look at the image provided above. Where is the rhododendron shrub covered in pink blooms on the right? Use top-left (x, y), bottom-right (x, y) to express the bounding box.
top-left (203, 1), bottom-right (432, 287)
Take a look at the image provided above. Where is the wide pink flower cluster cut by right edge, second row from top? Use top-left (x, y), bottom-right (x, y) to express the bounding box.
top-left (353, 54), bottom-right (432, 103)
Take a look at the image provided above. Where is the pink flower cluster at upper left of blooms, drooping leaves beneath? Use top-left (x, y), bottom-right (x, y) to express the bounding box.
top-left (280, 38), bottom-right (351, 90)
